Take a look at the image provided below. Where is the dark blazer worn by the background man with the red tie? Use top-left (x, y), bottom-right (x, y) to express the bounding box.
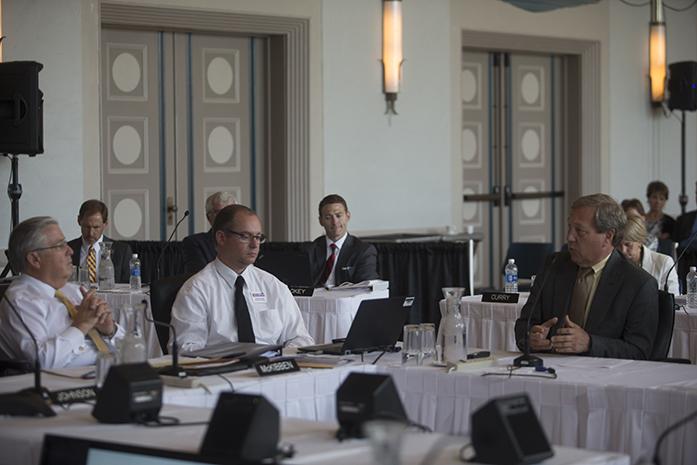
top-left (309, 234), bottom-right (380, 286)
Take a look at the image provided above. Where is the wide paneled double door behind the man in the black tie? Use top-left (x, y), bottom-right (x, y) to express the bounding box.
top-left (101, 28), bottom-right (265, 240)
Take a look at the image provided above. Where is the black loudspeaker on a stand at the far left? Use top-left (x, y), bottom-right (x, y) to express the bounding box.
top-left (0, 61), bottom-right (44, 155)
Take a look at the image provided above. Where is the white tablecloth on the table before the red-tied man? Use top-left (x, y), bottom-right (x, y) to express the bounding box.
top-left (295, 289), bottom-right (390, 344)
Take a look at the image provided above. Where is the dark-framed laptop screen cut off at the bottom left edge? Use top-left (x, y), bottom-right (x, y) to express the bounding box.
top-left (41, 434), bottom-right (229, 465)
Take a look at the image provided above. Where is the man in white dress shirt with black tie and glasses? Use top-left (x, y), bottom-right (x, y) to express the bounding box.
top-left (170, 205), bottom-right (314, 352)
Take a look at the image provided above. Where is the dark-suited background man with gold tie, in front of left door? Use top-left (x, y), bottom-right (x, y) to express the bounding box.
top-left (68, 199), bottom-right (133, 283)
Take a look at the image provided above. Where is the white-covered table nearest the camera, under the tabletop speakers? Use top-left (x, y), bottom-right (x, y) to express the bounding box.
top-left (0, 405), bottom-right (630, 465)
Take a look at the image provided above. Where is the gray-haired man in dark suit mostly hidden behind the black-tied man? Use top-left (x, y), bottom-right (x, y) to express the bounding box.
top-left (182, 192), bottom-right (237, 273)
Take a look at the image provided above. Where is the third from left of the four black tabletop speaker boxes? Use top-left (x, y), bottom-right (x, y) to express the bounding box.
top-left (336, 373), bottom-right (409, 439)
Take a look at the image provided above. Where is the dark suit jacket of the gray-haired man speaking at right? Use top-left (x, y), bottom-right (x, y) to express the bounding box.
top-left (515, 250), bottom-right (658, 360)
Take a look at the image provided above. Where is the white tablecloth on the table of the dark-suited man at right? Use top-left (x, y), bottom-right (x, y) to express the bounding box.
top-left (378, 355), bottom-right (697, 465)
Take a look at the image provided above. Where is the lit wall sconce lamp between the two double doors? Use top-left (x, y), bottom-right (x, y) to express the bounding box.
top-left (382, 0), bottom-right (404, 115)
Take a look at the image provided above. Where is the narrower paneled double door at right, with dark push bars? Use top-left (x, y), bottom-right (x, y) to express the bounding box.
top-left (460, 50), bottom-right (566, 287)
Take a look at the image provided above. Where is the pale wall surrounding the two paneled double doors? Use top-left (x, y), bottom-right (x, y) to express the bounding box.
top-left (0, 0), bottom-right (697, 247)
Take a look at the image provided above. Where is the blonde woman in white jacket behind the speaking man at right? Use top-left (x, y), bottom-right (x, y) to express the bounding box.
top-left (617, 214), bottom-right (680, 295)
